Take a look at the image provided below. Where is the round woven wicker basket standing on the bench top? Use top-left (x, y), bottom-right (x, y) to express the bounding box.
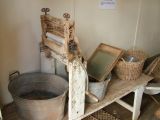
top-left (115, 50), bottom-right (146, 80)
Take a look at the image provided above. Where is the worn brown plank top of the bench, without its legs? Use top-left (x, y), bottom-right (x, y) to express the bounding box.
top-left (64, 74), bottom-right (153, 120)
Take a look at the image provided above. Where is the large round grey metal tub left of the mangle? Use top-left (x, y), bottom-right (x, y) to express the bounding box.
top-left (8, 73), bottom-right (68, 120)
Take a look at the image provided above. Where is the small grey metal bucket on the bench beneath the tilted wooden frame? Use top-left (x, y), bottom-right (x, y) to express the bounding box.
top-left (86, 74), bottom-right (111, 103)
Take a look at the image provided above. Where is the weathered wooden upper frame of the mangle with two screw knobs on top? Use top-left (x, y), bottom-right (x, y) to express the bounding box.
top-left (41, 8), bottom-right (80, 64)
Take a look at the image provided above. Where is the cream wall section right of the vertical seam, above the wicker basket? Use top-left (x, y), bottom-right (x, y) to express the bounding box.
top-left (136, 0), bottom-right (160, 55)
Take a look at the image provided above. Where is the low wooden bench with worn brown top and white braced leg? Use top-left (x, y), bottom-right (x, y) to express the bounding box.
top-left (64, 74), bottom-right (153, 120)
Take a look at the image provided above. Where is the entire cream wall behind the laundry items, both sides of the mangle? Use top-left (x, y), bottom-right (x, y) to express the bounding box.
top-left (0, 0), bottom-right (160, 104)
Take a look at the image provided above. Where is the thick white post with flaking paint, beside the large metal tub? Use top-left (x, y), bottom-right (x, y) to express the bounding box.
top-left (69, 59), bottom-right (86, 120)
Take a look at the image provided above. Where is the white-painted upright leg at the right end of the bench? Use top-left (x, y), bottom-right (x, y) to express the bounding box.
top-left (132, 86), bottom-right (144, 120)
